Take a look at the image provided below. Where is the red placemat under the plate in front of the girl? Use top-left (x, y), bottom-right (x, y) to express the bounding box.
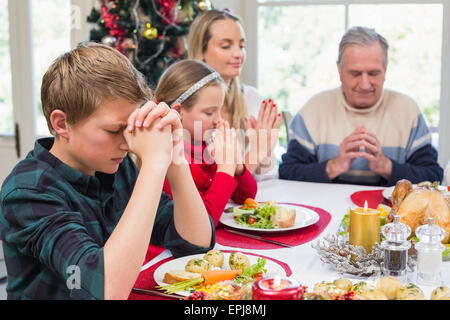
top-left (216, 203), bottom-right (331, 249)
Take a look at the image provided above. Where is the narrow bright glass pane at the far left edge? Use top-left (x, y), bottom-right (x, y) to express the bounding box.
top-left (0, 0), bottom-right (14, 135)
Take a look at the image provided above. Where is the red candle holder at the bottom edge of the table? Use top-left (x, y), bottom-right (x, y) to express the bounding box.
top-left (252, 276), bottom-right (305, 300)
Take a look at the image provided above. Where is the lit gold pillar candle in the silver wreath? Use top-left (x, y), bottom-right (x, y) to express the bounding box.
top-left (349, 201), bottom-right (380, 253)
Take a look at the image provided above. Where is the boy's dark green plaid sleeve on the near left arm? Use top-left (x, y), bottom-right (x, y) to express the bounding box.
top-left (0, 188), bottom-right (104, 299)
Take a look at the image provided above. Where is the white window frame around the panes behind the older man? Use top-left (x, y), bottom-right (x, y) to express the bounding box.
top-left (243, 0), bottom-right (450, 168)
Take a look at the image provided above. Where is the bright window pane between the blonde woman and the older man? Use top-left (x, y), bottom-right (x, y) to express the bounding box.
top-left (258, 5), bottom-right (345, 147)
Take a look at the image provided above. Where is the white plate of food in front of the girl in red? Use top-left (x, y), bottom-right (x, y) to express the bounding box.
top-left (220, 203), bottom-right (320, 232)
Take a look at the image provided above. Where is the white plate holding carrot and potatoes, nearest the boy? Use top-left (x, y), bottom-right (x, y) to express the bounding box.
top-left (153, 251), bottom-right (286, 296)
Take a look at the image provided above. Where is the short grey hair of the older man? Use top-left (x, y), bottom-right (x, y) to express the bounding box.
top-left (337, 26), bottom-right (389, 69)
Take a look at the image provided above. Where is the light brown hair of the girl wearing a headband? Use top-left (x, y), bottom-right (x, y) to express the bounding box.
top-left (155, 59), bottom-right (225, 109)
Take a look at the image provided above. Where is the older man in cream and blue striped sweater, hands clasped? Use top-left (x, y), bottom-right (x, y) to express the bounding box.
top-left (279, 27), bottom-right (443, 186)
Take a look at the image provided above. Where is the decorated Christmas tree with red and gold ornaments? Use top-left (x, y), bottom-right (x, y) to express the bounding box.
top-left (87, 0), bottom-right (211, 88)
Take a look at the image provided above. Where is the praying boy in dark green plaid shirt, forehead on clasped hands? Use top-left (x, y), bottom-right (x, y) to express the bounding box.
top-left (0, 43), bottom-right (215, 299)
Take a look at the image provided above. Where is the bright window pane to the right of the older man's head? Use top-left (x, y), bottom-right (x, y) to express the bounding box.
top-left (349, 4), bottom-right (443, 129)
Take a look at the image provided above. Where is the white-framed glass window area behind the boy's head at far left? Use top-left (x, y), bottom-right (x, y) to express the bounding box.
top-left (0, 0), bottom-right (84, 182)
